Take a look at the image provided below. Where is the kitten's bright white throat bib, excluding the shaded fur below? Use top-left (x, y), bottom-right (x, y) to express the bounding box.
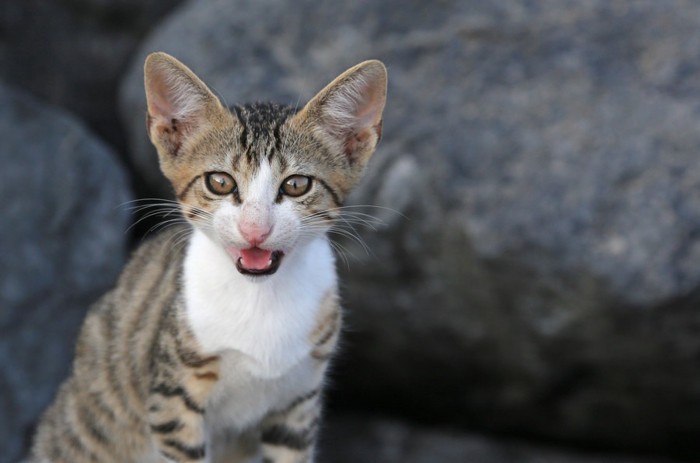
top-left (183, 229), bottom-right (336, 377)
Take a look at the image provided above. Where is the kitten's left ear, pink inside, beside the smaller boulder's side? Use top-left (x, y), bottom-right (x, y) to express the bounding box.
top-left (144, 52), bottom-right (222, 156)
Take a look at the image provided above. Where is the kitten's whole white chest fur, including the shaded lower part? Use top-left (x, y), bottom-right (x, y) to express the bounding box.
top-left (184, 230), bottom-right (336, 424)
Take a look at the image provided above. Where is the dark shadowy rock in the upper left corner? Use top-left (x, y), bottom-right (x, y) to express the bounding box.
top-left (0, 0), bottom-right (186, 147)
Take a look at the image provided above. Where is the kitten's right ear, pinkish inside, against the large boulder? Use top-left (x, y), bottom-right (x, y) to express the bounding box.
top-left (299, 60), bottom-right (387, 167)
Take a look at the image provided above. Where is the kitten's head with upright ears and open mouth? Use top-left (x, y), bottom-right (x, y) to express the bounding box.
top-left (145, 53), bottom-right (387, 276)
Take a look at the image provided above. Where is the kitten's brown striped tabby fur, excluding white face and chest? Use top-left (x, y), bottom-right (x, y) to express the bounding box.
top-left (31, 53), bottom-right (386, 463)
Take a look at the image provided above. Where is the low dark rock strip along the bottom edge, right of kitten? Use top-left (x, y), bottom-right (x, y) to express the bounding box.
top-left (319, 415), bottom-right (672, 463)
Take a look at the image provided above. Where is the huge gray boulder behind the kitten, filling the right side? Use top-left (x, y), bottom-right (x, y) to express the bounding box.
top-left (120, 0), bottom-right (700, 454)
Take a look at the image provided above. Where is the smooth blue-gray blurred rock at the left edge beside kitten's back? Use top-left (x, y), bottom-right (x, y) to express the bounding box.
top-left (0, 85), bottom-right (131, 463)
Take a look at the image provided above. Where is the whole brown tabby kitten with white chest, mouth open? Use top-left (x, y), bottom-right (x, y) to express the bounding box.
top-left (32, 53), bottom-right (387, 463)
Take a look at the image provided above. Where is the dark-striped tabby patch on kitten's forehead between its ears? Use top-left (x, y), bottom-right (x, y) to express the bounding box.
top-left (232, 103), bottom-right (295, 168)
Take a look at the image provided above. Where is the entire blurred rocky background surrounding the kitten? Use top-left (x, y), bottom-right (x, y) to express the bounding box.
top-left (0, 0), bottom-right (700, 463)
